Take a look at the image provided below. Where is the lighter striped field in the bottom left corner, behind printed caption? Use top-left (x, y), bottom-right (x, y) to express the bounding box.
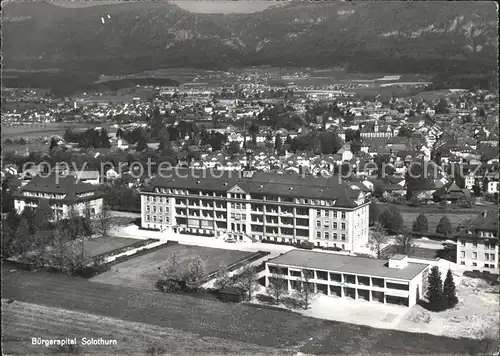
top-left (2, 301), bottom-right (280, 355)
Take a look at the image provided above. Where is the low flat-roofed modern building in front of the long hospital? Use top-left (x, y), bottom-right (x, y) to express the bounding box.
top-left (266, 249), bottom-right (429, 307)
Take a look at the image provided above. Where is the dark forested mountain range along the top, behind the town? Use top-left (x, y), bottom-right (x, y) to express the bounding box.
top-left (2, 1), bottom-right (498, 74)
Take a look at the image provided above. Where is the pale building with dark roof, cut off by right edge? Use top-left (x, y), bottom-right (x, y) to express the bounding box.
top-left (457, 209), bottom-right (500, 274)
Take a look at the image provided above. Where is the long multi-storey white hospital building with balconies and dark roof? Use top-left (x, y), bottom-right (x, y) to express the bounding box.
top-left (141, 170), bottom-right (369, 252)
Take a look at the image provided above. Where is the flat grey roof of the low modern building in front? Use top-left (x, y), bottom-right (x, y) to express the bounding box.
top-left (268, 250), bottom-right (428, 281)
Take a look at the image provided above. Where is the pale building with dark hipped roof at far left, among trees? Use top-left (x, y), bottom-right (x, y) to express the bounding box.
top-left (14, 173), bottom-right (103, 220)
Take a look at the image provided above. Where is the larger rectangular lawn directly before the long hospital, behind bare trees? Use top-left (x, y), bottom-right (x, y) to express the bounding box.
top-left (92, 244), bottom-right (252, 290)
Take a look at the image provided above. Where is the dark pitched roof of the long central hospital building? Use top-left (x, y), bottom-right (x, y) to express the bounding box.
top-left (143, 169), bottom-right (361, 208)
